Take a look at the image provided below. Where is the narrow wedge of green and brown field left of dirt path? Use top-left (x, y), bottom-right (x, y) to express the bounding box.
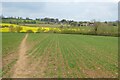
top-left (1, 33), bottom-right (25, 77)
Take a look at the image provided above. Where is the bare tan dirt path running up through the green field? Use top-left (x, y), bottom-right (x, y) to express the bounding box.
top-left (13, 34), bottom-right (28, 78)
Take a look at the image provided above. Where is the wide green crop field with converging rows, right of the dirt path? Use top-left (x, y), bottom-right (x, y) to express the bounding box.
top-left (27, 33), bottom-right (118, 77)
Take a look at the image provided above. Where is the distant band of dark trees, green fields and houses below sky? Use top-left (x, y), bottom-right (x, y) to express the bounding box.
top-left (0, 16), bottom-right (117, 26)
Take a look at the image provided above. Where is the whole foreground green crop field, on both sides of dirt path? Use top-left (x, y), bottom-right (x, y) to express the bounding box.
top-left (2, 33), bottom-right (118, 78)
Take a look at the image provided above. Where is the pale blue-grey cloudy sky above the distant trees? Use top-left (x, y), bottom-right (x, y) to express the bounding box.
top-left (2, 0), bottom-right (118, 21)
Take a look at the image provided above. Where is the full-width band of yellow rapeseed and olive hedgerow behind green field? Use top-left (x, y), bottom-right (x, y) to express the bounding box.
top-left (0, 23), bottom-right (119, 36)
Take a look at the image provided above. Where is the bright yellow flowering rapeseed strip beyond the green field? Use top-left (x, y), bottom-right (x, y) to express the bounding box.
top-left (0, 23), bottom-right (80, 33)
